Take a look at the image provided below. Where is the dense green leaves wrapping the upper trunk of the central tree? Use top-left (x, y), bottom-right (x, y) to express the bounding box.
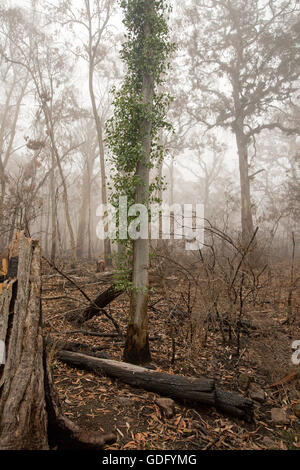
top-left (106, 0), bottom-right (174, 288)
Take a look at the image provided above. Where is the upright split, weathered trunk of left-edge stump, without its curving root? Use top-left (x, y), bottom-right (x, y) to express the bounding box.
top-left (0, 237), bottom-right (48, 450)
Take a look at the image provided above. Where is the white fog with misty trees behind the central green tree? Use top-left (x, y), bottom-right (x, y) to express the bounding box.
top-left (0, 0), bottom-right (300, 262)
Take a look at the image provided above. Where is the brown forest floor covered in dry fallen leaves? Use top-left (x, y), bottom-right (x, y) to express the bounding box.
top-left (42, 263), bottom-right (300, 450)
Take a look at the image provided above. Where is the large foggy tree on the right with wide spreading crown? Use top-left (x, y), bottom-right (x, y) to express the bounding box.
top-left (182, 0), bottom-right (300, 244)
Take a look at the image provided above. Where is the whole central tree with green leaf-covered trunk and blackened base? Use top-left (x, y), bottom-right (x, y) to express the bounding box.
top-left (107, 0), bottom-right (172, 363)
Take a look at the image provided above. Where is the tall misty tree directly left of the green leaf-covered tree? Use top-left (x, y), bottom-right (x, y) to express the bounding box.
top-left (51, 0), bottom-right (116, 265)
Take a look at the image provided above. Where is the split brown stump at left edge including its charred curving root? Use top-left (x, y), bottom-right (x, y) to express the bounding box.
top-left (0, 233), bottom-right (115, 450)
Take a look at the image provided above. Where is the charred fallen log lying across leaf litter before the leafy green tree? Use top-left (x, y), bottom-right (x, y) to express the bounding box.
top-left (56, 350), bottom-right (253, 420)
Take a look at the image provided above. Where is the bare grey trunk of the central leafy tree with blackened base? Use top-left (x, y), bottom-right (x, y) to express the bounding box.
top-left (124, 8), bottom-right (154, 364)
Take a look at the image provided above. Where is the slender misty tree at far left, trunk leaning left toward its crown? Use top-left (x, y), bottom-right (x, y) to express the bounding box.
top-left (1, 9), bottom-right (82, 264)
